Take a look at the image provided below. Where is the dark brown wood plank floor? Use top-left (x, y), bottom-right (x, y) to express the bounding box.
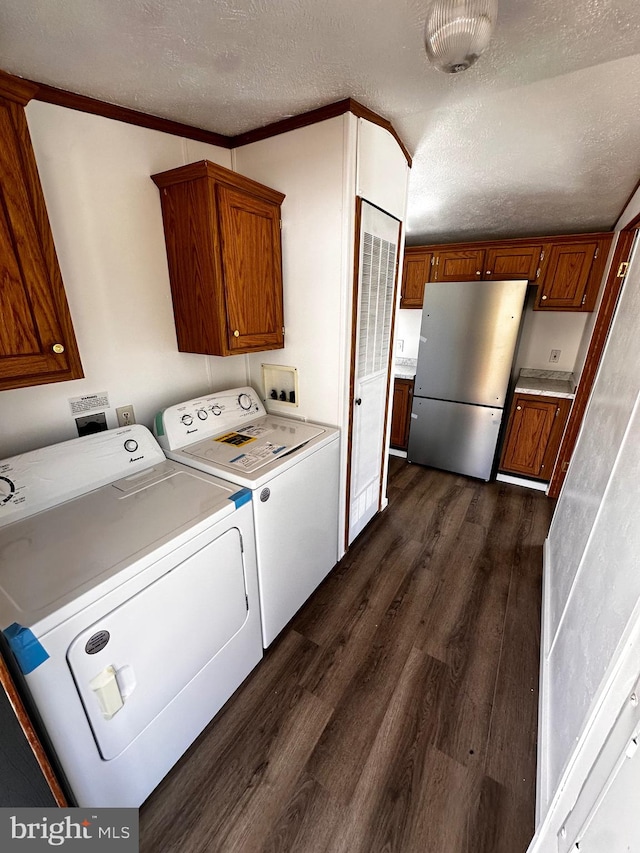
top-left (140, 457), bottom-right (553, 853)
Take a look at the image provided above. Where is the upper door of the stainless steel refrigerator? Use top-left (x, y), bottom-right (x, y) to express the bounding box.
top-left (414, 281), bottom-right (527, 408)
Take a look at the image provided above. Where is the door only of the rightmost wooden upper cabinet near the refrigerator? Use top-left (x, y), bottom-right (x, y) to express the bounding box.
top-left (535, 240), bottom-right (599, 311)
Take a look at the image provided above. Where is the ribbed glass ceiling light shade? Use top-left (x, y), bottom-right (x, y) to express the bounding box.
top-left (424, 0), bottom-right (498, 74)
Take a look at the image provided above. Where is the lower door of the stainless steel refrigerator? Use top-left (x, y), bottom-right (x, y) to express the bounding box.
top-left (407, 397), bottom-right (503, 480)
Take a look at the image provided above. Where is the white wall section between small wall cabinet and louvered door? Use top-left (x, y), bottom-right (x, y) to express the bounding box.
top-left (234, 115), bottom-right (355, 426)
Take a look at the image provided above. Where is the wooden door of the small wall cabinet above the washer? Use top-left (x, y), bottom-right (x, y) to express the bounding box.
top-left (216, 184), bottom-right (284, 352)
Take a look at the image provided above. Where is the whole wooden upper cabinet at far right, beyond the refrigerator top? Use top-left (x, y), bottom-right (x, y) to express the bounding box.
top-left (535, 234), bottom-right (612, 311)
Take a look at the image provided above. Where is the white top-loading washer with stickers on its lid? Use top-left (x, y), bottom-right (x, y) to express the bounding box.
top-left (154, 387), bottom-right (340, 648)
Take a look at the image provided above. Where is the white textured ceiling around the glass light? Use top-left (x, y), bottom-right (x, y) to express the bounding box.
top-left (0, 0), bottom-right (640, 244)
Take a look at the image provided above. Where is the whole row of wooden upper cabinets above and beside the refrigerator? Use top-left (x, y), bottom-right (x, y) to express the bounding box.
top-left (400, 232), bottom-right (613, 311)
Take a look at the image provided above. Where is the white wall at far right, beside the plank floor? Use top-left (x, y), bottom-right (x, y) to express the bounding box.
top-left (530, 185), bottom-right (640, 853)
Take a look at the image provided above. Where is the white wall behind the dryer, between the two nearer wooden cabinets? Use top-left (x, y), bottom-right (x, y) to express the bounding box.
top-left (0, 101), bottom-right (246, 458)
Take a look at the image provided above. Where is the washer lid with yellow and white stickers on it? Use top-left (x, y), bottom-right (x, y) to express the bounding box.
top-left (183, 415), bottom-right (326, 474)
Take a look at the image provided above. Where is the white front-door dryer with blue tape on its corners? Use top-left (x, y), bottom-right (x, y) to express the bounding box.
top-left (0, 425), bottom-right (263, 807)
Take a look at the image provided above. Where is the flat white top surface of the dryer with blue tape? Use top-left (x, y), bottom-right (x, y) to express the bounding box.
top-left (0, 461), bottom-right (245, 632)
